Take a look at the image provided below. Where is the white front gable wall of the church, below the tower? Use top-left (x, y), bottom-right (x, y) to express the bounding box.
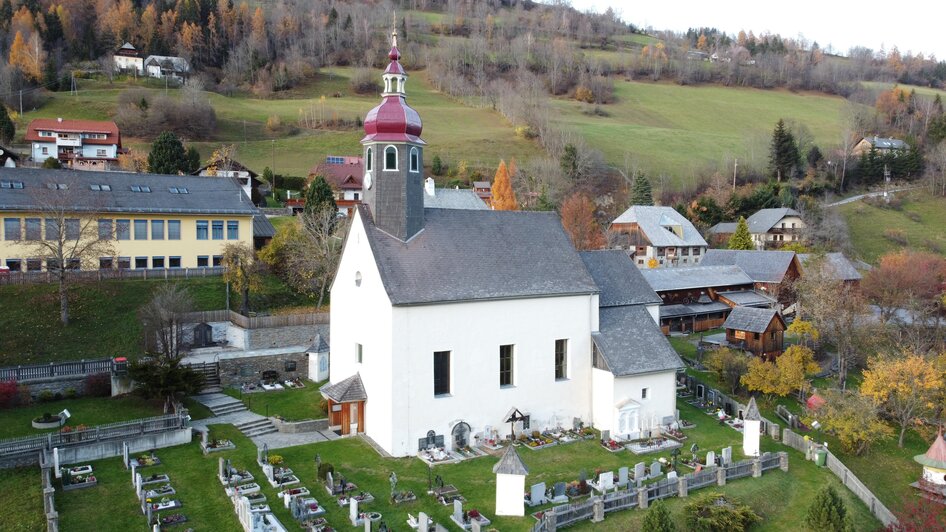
top-left (329, 211), bottom-right (392, 452)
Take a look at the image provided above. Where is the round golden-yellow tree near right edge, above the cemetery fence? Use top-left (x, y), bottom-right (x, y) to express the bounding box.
top-left (861, 354), bottom-right (943, 448)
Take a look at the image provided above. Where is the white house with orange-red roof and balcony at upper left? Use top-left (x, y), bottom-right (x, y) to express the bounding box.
top-left (25, 118), bottom-right (122, 170)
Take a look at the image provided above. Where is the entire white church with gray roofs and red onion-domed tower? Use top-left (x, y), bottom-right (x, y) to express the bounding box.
top-left (321, 32), bottom-right (683, 456)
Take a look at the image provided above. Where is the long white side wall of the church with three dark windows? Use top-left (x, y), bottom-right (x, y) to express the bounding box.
top-left (382, 295), bottom-right (597, 456)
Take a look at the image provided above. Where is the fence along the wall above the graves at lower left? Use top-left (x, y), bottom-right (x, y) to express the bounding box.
top-left (0, 412), bottom-right (187, 458)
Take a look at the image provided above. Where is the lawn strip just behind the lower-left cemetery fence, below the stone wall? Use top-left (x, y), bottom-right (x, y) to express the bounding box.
top-left (0, 395), bottom-right (164, 439)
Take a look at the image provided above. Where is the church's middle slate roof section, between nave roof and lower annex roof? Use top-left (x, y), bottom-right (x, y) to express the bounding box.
top-left (579, 249), bottom-right (660, 308)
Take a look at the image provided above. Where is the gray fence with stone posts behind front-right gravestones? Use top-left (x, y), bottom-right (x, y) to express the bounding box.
top-left (532, 452), bottom-right (788, 532)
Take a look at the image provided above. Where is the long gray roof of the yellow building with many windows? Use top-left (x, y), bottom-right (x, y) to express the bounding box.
top-left (0, 168), bottom-right (257, 215)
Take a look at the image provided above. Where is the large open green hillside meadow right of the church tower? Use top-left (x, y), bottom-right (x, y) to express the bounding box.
top-left (553, 81), bottom-right (846, 186)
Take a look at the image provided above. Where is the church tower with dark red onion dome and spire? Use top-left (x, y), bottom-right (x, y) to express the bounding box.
top-left (361, 30), bottom-right (426, 242)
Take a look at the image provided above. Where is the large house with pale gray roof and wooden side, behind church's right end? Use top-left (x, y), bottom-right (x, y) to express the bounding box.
top-left (611, 205), bottom-right (707, 269)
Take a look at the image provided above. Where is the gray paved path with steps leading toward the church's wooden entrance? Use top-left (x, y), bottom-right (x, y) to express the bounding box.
top-left (191, 393), bottom-right (338, 449)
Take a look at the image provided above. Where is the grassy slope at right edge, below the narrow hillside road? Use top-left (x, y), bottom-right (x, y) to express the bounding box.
top-left (841, 190), bottom-right (946, 263)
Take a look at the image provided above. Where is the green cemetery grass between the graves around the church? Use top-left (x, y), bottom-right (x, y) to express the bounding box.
top-left (11, 403), bottom-right (877, 531)
